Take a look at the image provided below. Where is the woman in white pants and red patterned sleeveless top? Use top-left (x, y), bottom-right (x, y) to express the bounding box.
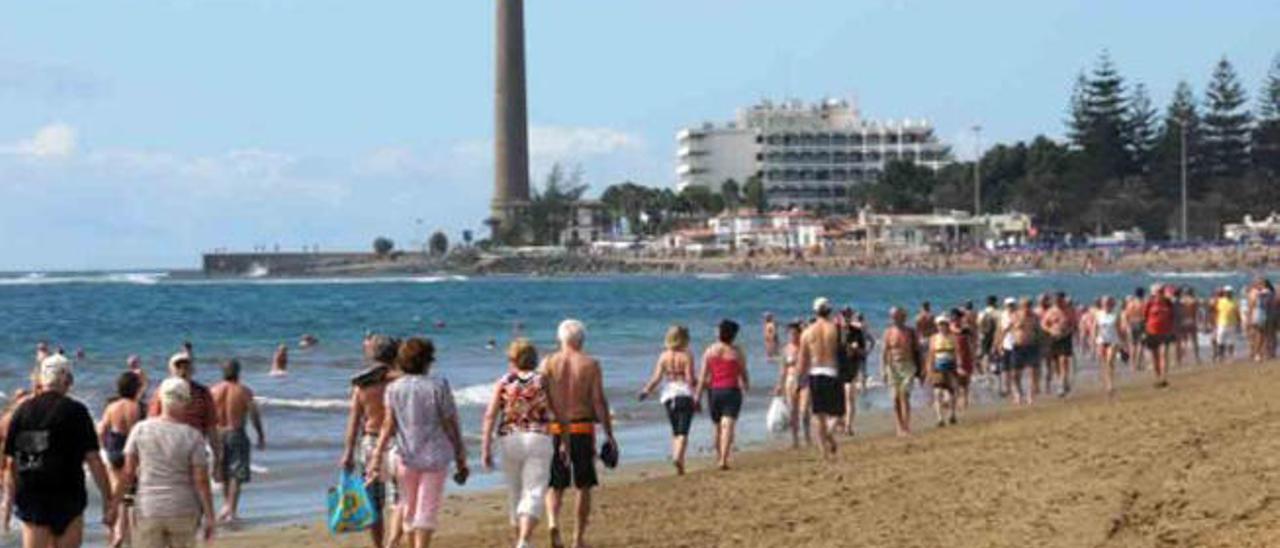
top-left (480, 338), bottom-right (570, 548)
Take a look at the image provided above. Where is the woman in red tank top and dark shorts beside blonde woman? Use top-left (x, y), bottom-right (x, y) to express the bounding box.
top-left (694, 320), bottom-right (749, 470)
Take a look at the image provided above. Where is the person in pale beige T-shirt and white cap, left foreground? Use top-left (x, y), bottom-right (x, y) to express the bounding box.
top-left (115, 376), bottom-right (215, 548)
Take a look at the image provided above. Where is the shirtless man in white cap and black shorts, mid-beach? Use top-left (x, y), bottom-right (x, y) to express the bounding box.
top-left (799, 297), bottom-right (845, 460)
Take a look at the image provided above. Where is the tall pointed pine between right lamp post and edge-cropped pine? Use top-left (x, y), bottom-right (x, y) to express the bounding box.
top-left (1204, 58), bottom-right (1252, 178)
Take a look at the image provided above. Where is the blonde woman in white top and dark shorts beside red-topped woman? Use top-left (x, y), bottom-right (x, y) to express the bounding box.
top-left (640, 325), bottom-right (695, 475)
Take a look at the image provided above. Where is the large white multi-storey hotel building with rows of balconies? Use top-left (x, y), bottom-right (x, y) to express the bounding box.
top-left (676, 100), bottom-right (950, 209)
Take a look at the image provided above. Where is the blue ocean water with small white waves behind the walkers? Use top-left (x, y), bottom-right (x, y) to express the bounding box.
top-left (0, 271), bottom-right (1249, 540)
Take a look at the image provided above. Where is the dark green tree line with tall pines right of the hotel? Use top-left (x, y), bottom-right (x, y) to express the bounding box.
top-left (855, 51), bottom-right (1280, 239)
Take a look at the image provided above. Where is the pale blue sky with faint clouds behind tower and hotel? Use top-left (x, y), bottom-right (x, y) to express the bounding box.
top-left (0, 0), bottom-right (1280, 270)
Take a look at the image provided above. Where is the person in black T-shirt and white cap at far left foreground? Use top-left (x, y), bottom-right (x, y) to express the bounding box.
top-left (5, 355), bottom-right (115, 548)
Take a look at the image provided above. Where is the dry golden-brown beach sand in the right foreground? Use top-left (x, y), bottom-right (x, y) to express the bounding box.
top-left (224, 364), bottom-right (1280, 548)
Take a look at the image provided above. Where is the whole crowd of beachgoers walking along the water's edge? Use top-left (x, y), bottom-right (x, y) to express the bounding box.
top-left (0, 278), bottom-right (1280, 548)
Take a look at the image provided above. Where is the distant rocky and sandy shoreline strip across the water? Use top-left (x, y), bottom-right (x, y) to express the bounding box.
top-left (189, 246), bottom-right (1280, 279)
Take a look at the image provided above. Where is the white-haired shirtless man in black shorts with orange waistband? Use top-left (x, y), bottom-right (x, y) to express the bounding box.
top-left (541, 320), bottom-right (618, 548)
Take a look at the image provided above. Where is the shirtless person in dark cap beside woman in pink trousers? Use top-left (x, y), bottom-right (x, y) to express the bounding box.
top-left (342, 334), bottom-right (401, 548)
